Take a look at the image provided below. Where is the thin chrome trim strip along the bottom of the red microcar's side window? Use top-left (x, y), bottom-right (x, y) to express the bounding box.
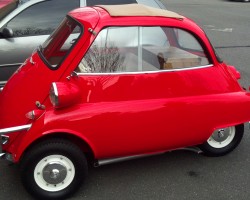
top-left (76, 64), bottom-right (213, 76)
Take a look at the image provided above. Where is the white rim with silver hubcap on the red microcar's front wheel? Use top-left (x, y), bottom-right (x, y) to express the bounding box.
top-left (34, 155), bottom-right (75, 192)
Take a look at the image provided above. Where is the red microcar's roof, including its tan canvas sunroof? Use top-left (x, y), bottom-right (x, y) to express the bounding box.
top-left (68, 4), bottom-right (206, 39)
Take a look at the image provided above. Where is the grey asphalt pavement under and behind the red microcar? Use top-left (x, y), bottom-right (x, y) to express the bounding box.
top-left (0, 0), bottom-right (250, 200)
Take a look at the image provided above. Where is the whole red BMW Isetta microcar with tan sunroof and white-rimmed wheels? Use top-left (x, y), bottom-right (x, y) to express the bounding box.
top-left (0, 4), bottom-right (250, 199)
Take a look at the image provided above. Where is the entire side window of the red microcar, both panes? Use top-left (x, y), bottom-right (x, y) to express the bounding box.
top-left (76, 26), bottom-right (209, 73)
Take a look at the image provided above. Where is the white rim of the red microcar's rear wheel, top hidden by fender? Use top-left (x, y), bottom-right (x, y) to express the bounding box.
top-left (207, 126), bottom-right (236, 149)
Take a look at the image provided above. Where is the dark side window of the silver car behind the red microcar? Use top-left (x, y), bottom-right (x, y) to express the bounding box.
top-left (7, 0), bottom-right (80, 37)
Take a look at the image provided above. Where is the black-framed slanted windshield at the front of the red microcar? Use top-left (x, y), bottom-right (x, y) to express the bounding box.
top-left (39, 18), bottom-right (81, 68)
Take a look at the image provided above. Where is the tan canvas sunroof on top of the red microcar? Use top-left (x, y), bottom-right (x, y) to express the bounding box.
top-left (95, 4), bottom-right (184, 19)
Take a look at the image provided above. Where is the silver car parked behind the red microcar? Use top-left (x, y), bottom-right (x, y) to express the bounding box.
top-left (0, 0), bottom-right (165, 87)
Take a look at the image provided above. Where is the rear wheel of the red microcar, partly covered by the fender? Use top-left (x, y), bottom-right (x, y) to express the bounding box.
top-left (199, 124), bottom-right (244, 156)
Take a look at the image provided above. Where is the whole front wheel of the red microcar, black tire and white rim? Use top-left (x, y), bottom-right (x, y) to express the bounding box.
top-left (21, 139), bottom-right (87, 199)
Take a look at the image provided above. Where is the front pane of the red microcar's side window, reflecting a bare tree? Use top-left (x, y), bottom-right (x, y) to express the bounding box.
top-left (76, 27), bottom-right (138, 73)
